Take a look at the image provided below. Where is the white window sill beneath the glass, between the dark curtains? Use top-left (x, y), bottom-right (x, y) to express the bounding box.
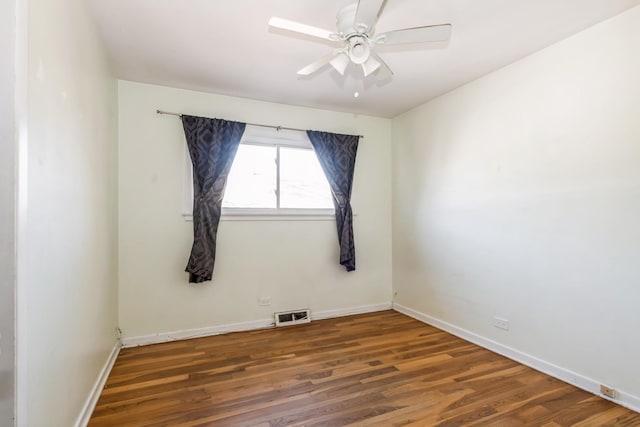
top-left (182, 209), bottom-right (336, 221)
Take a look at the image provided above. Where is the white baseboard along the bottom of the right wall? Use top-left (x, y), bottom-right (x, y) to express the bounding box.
top-left (393, 303), bottom-right (640, 412)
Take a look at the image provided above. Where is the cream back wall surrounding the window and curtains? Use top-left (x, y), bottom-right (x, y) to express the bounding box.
top-left (119, 81), bottom-right (391, 337)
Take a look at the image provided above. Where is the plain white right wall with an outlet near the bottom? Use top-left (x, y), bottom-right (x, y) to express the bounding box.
top-left (392, 7), bottom-right (640, 399)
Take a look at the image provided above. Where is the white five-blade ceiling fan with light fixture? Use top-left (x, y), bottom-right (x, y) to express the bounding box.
top-left (269, 0), bottom-right (451, 77)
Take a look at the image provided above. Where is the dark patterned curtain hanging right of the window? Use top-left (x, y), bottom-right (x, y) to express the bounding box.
top-left (307, 130), bottom-right (360, 271)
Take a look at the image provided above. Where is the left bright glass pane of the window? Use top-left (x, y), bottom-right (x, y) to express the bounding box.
top-left (222, 144), bottom-right (276, 208)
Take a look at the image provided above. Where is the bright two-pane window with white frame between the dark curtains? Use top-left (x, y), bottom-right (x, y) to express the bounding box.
top-left (186, 125), bottom-right (334, 218)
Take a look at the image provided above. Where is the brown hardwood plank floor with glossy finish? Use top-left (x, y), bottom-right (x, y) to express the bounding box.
top-left (89, 311), bottom-right (640, 427)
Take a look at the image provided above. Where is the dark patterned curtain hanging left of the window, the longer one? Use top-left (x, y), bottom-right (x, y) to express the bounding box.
top-left (182, 115), bottom-right (246, 283)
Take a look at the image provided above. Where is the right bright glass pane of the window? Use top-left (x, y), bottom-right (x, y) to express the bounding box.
top-left (280, 147), bottom-right (333, 209)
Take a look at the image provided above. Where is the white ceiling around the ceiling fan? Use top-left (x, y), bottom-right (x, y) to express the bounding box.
top-left (88, 0), bottom-right (640, 117)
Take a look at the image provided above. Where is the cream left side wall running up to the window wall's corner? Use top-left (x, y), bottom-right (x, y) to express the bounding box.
top-left (18, 0), bottom-right (117, 426)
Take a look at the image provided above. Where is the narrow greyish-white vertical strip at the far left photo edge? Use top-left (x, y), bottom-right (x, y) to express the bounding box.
top-left (0, 0), bottom-right (16, 426)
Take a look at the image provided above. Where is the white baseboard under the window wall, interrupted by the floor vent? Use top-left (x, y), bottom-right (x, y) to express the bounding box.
top-left (122, 303), bottom-right (391, 348)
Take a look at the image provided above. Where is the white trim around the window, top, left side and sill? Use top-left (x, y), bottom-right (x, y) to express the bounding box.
top-left (182, 125), bottom-right (335, 221)
